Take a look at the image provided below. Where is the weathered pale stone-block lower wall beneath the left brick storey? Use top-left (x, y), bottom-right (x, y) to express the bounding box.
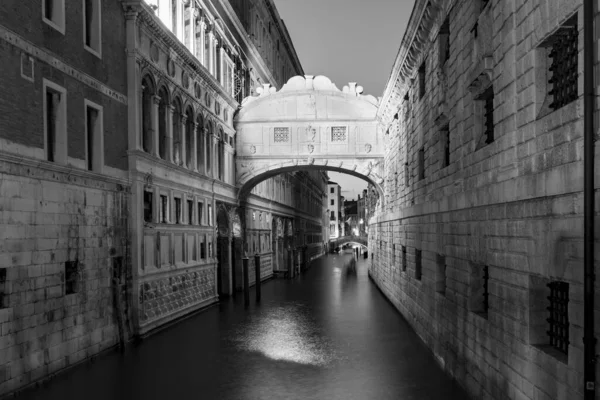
top-left (0, 155), bottom-right (129, 396)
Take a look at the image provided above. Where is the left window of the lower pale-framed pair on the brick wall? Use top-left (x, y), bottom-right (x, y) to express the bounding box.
top-left (43, 79), bottom-right (67, 164)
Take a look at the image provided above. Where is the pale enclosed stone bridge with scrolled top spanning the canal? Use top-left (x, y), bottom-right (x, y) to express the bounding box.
top-left (235, 75), bottom-right (384, 199)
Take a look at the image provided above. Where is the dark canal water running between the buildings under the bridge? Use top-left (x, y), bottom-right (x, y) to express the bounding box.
top-left (17, 252), bottom-right (467, 400)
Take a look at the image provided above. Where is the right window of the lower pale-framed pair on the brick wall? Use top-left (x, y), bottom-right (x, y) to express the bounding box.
top-left (84, 100), bottom-right (104, 173)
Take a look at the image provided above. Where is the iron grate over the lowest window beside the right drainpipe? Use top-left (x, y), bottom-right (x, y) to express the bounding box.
top-left (546, 281), bottom-right (569, 354)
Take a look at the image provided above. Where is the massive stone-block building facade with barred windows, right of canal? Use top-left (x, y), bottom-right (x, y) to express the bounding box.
top-left (376, 0), bottom-right (597, 399)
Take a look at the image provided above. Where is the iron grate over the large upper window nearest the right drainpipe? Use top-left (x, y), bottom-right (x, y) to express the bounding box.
top-left (548, 19), bottom-right (578, 110)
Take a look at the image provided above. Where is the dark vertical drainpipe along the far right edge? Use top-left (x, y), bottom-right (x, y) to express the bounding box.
top-left (583, 0), bottom-right (596, 400)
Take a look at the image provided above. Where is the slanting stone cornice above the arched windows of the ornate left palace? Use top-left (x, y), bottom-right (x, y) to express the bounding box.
top-left (138, 2), bottom-right (238, 109)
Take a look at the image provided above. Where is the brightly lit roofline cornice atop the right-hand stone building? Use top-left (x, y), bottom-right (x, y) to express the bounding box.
top-left (378, 0), bottom-right (456, 125)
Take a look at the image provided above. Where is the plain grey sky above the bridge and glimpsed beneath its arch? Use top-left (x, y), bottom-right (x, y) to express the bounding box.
top-left (275, 0), bottom-right (414, 200)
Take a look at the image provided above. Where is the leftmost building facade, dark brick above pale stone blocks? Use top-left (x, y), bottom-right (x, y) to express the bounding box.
top-left (0, 0), bottom-right (131, 395)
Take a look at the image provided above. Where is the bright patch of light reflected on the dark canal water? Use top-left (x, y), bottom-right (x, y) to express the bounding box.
top-left (236, 305), bottom-right (335, 366)
